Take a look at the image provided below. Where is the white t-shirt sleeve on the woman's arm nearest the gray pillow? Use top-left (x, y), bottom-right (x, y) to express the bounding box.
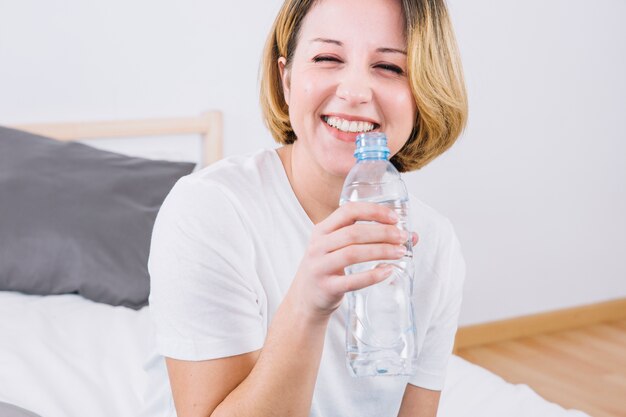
top-left (148, 177), bottom-right (265, 360)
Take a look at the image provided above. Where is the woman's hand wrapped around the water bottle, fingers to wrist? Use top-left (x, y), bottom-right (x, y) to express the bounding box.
top-left (287, 203), bottom-right (417, 319)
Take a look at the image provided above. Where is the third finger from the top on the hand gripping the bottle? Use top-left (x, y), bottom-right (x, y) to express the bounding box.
top-left (323, 243), bottom-right (406, 274)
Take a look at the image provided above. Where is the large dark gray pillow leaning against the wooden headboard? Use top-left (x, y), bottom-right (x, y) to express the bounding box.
top-left (0, 127), bottom-right (194, 309)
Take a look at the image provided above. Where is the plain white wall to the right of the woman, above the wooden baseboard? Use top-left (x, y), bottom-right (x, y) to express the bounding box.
top-left (404, 0), bottom-right (626, 323)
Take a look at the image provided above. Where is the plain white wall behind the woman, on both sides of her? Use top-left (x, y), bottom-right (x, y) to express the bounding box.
top-left (0, 0), bottom-right (626, 324)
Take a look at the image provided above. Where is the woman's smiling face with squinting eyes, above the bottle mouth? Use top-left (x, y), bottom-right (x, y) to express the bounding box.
top-left (278, 0), bottom-right (416, 177)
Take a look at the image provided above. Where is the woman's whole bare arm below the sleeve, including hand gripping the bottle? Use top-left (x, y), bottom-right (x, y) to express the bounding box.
top-left (168, 203), bottom-right (407, 417)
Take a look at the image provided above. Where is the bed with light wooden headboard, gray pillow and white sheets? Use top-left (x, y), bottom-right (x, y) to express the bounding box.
top-left (0, 112), bottom-right (586, 417)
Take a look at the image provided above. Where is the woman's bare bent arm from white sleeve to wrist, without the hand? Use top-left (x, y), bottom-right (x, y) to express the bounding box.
top-left (166, 292), bottom-right (327, 417)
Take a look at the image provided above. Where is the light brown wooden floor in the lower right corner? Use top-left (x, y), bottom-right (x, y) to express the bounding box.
top-left (457, 320), bottom-right (626, 417)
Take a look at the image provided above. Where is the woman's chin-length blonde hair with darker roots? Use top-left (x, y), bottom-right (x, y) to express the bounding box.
top-left (260, 0), bottom-right (467, 172)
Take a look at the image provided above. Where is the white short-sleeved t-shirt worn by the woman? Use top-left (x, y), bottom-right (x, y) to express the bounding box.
top-left (146, 149), bottom-right (465, 417)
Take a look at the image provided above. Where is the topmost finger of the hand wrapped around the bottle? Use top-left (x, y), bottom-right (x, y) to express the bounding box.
top-left (318, 202), bottom-right (398, 234)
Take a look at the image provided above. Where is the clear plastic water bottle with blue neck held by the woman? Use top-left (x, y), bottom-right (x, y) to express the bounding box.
top-left (339, 132), bottom-right (417, 376)
